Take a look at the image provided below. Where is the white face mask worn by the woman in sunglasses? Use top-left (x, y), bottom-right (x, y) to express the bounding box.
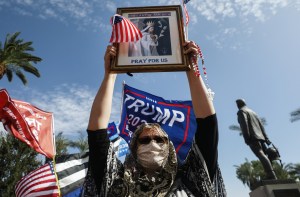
top-left (137, 140), bottom-right (169, 170)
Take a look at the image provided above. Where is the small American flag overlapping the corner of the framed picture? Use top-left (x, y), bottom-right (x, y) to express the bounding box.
top-left (109, 14), bottom-right (142, 43)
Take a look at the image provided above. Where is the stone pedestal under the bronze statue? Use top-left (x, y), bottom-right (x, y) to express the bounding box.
top-left (249, 180), bottom-right (300, 197)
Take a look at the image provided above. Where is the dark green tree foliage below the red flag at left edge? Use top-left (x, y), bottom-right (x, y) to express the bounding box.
top-left (0, 133), bottom-right (42, 197)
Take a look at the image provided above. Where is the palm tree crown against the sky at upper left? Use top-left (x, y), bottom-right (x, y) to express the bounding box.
top-left (0, 32), bottom-right (42, 85)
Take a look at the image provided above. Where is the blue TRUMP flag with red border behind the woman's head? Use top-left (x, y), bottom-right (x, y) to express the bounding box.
top-left (119, 84), bottom-right (196, 162)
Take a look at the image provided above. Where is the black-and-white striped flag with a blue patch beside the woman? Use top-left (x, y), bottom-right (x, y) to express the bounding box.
top-left (55, 152), bottom-right (89, 197)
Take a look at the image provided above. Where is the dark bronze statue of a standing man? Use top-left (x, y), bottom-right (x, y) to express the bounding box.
top-left (236, 99), bottom-right (277, 179)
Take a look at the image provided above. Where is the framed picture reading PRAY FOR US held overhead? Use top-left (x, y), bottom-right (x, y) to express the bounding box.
top-left (111, 5), bottom-right (189, 73)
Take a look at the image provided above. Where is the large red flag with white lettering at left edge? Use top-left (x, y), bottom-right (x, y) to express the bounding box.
top-left (0, 89), bottom-right (55, 158)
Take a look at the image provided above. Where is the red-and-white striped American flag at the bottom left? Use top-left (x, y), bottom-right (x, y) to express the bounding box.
top-left (15, 162), bottom-right (59, 197)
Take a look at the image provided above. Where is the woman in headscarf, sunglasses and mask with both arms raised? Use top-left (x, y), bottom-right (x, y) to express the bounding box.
top-left (84, 42), bottom-right (226, 197)
